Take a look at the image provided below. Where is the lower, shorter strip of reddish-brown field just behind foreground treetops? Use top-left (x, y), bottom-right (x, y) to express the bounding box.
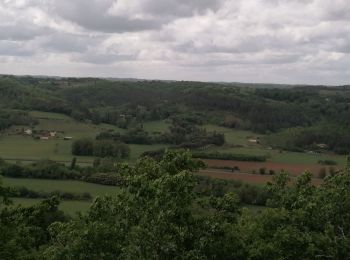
top-left (198, 169), bottom-right (322, 185)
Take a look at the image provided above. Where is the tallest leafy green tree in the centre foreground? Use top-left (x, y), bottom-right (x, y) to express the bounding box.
top-left (45, 151), bottom-right (246, 259)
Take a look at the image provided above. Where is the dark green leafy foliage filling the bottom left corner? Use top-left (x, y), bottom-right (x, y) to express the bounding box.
top-left (0, 198), bottom-right (67, 260)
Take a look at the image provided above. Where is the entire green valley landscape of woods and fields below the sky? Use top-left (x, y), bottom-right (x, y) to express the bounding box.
top-left (0, 76), bottom-right (350, 259)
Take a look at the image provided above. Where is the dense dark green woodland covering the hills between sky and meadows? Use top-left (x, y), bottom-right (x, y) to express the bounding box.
top-left (0, 76), bottom-right (350, 154)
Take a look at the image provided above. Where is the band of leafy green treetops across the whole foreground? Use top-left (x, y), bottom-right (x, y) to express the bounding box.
top-left (0, 152), bottom-right (350, 259)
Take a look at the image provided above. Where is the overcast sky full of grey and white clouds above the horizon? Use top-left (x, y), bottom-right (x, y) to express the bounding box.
top-left (0, 0), bottom-right (350, 84)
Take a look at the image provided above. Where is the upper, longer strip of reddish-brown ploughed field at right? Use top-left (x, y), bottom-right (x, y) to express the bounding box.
top-left (203, 159), bottom-right (339, 177)
